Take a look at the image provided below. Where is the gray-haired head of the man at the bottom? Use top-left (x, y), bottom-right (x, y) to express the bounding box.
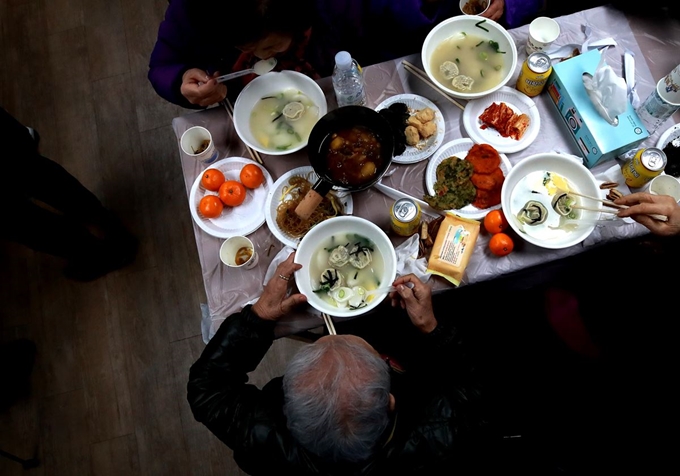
top-left (283, 336), bottom-right (390, 462)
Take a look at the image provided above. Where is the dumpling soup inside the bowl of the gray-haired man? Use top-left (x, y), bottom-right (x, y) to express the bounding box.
top-left (309, 233), bottom-right (382, 309)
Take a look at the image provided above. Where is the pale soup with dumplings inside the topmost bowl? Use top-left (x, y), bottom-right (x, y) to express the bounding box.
top-left (430, 33), bottom-right (507, 93)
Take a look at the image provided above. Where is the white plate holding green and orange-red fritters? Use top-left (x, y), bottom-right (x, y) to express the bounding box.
top-left (423, 139), bottom-right (512, 220)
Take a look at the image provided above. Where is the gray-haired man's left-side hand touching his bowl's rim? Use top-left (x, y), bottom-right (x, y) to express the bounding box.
top-left (253, 252), bottom-right (307, 321)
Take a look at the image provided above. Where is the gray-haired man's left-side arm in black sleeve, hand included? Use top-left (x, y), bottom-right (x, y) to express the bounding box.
top-left (187, 254), bottom-right (305, 450)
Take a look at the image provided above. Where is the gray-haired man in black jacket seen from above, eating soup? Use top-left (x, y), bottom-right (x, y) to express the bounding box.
top-left (188, 254), bottom-right (499, 475)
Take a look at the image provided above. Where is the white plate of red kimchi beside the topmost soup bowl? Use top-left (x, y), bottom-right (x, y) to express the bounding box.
top-left (463, 86), bottom-right (541, 154)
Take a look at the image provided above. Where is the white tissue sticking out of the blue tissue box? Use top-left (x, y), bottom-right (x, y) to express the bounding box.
top-left (583, 53), bottom-right (628, 126)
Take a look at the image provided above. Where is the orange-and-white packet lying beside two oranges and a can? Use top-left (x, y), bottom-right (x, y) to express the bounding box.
top-left (427, 212), bottom-right (480, 286)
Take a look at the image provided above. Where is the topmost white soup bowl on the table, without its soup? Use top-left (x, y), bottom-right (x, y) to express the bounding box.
top-left (421, 15), bottom-right (517, 99)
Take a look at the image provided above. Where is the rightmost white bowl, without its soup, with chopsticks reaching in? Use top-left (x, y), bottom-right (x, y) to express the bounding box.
top-left (501, 153), bottom-right (602, 249)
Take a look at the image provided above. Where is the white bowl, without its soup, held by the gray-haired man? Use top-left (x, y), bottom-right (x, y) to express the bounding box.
top-left (295, 216), bottom-right (397, 317)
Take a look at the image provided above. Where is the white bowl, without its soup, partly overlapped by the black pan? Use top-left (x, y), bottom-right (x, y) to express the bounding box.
top-left (234, 71), bottom-right (328, 155)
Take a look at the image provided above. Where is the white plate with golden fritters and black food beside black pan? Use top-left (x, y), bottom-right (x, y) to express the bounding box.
top-left (375, 94), bottom-right (446, 164)
